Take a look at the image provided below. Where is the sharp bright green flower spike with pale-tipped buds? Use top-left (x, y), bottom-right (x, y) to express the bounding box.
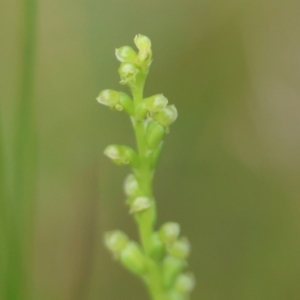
top-left (97, 35), bottom-right (194, 300)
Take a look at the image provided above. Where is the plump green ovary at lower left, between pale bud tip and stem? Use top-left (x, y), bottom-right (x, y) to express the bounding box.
top-left (120, 242), bottom-right (146, 275)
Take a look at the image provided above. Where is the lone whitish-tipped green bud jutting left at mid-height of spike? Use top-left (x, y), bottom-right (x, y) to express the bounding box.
top-left (104, 145), bottom-right (138, 167)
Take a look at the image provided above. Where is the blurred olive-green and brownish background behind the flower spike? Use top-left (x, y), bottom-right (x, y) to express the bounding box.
top-left (0, 0), bottom-right (300, 300)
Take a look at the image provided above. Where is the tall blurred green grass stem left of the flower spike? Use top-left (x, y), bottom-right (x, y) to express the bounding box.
top-left (10, 0), bottom-right (37, 300)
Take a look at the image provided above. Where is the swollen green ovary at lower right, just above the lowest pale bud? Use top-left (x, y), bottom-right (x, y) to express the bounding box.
top-left (162, 256), bottom-right (185, 289)
